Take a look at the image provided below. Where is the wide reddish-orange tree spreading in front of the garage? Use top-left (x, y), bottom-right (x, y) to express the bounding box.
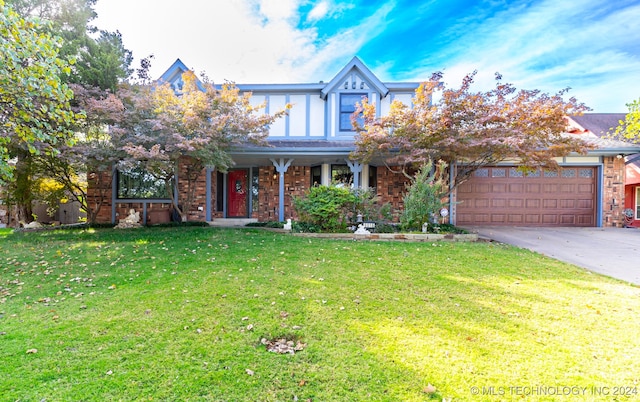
top-left (352, 72), bottom-right (589, 191)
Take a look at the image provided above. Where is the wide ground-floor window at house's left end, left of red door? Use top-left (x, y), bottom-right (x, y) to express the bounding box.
top-left (118, 167), bottom-right (171, 199)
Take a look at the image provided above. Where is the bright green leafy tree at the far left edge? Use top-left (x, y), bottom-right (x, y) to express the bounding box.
top-left (0, 0), bottom-right (80, 180)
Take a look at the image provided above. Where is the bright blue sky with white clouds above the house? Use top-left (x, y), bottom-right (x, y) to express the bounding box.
top-left (94, 0), bottom-right (640, 113)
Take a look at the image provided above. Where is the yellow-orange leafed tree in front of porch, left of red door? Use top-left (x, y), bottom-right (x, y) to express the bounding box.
top-left (119, 71), bottom-right (289, 221)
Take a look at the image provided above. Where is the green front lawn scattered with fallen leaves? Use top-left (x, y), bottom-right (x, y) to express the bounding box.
top-left (0, 227), bottom-right (640, 401)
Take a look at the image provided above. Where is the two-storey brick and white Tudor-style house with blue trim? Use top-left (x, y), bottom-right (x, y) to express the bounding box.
top-left (89, 57), bottom-right (640, 226)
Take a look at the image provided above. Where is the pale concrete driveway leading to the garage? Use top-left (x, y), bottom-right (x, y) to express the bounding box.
top-left (465, 226), bottom-right (640, 285)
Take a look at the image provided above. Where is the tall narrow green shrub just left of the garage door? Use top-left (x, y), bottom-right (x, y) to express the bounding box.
top-left (400, 162), bottom-right (447, 230)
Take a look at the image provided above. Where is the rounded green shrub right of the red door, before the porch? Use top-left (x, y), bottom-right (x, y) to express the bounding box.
top-left (293, 186), bottom-right (356, 232)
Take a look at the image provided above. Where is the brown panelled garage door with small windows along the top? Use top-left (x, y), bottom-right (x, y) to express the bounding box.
top-left (456, 166), bottom-right (596, 226)
